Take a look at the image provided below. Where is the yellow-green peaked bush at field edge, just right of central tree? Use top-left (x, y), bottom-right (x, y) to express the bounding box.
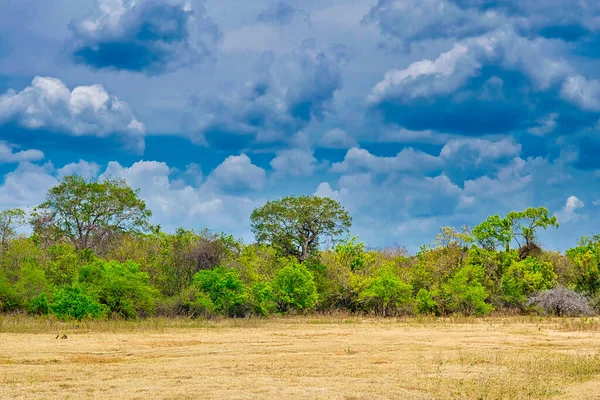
top-left (359, 268), bottom-right (412, 316)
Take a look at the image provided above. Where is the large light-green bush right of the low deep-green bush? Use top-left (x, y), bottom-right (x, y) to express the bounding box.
top-left (79, 259), bottom-right (159, 318)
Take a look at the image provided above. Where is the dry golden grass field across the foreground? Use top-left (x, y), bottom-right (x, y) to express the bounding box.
top-left (0, 316), bottom-right (600, 400)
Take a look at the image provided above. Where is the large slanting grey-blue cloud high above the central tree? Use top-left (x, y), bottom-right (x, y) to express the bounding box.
top-left (195, 40), bottom-right (346, 150)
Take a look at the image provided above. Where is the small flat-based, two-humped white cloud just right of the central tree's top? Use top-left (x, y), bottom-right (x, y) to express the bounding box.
top-left (331, 147), bottom-right (443, 173)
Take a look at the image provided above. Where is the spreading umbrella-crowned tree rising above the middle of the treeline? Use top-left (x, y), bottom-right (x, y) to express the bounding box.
top-left (250, 196), bottom-right (352, 262)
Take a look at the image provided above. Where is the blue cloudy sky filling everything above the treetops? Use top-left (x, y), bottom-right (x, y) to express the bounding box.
top-left (0, 0), bottom-right (600, 249)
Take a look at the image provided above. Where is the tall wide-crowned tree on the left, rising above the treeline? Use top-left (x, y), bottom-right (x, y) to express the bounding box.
top-left (32, 175), bottom-right (152, 251)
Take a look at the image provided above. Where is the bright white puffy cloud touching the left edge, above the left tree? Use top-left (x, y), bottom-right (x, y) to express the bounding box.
top-left (0, 76), bottom-right (145, 150)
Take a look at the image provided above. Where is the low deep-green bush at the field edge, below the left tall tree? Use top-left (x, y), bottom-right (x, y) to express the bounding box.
top-left (50, 286), bottom-right (109, 320)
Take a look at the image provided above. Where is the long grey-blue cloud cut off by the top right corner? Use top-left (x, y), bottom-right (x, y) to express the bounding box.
top-left (363, 0), bottom-right (600, 50)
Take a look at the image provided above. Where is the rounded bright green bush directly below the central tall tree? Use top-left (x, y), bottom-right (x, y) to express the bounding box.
top-left (273, 264), bottom-right (319, 312)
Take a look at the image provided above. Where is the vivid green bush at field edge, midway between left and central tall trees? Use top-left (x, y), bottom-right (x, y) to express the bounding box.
top-left (193, 267), bottom-right (249, 317)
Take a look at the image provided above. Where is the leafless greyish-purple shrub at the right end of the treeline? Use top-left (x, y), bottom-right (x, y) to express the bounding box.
top-left (527, 286), bottom-right (594, 317)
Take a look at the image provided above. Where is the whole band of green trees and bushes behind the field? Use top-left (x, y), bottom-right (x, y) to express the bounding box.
top-left (0, 176), bottom-right (600, 319)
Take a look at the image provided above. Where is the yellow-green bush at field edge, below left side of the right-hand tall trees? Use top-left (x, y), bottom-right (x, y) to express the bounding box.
top-left (442, 265), bottom-right (494, 315)
